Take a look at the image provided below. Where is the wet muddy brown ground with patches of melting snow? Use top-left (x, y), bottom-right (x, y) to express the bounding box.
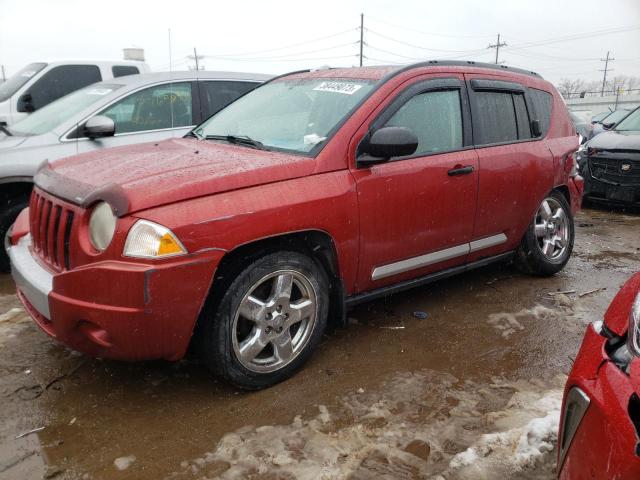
top-left (0, 210), bottom-right (640, 480)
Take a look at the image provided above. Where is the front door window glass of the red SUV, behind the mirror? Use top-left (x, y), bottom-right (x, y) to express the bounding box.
top-left (385, 90), bottom-right (462, 156)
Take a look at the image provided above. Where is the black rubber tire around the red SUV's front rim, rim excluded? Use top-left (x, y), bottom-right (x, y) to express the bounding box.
top-left (194, 251), bottom-right (329, 390)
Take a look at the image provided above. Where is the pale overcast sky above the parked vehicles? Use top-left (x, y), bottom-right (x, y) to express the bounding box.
top-left (0, 0), bottom-right (640, 82)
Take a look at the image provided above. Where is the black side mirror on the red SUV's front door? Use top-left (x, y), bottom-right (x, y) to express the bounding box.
top-left (357, 127), bottom-right (418, 167)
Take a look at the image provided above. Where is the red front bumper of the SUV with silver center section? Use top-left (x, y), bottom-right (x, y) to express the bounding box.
top-left (6, 235), bottom-right (223, 361)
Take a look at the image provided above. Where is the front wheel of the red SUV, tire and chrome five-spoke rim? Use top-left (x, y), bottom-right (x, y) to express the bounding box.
top-left (195, 252), bottom-right (329, 390)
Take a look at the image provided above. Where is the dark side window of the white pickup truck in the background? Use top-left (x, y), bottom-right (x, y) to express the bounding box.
top-left (23, 65), bottom-right (102, 110)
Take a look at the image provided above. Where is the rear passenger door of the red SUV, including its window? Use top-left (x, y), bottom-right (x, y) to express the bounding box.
top-left (466, 74), bottom-right (554, 261)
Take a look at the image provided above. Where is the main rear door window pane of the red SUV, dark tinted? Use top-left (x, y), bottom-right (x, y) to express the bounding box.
top-left (473, 91), bottom-right (518, 145)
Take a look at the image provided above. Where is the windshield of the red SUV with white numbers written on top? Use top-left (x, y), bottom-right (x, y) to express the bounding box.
top-left (195, 79), bottom-right (374, 153)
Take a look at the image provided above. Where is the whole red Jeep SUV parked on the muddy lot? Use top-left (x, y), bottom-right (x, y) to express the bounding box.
top-left (7, 61), bottom-right (582, 388)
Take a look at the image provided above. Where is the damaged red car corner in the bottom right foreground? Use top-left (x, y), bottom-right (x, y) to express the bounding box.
top-left (558, 273), bottom-right (640, 480)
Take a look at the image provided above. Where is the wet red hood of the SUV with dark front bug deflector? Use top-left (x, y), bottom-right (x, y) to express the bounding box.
top-left (35, 138), bottom-right (316, 216)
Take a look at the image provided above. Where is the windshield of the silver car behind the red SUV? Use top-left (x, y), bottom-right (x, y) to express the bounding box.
top-left (11, 84), bottom-right (122, 135)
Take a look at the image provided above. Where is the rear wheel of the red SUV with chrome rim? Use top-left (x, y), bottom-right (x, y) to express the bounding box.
top-left (516, 192), bottom-right (575, 276)
